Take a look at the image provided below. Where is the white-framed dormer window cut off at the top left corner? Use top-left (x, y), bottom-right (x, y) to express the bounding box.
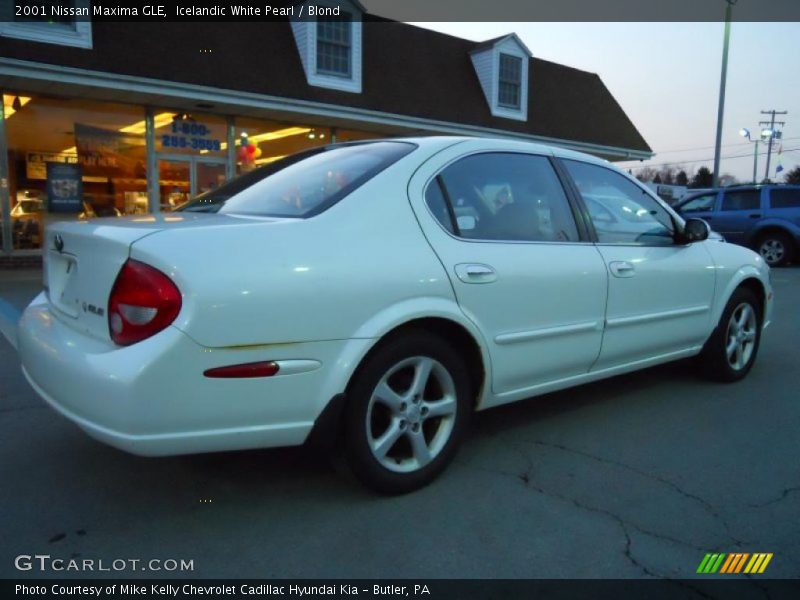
top-left (0, 0), bottom-right (92, 48)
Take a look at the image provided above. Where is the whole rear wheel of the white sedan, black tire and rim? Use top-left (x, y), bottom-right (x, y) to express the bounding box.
top-left (342, 330), bottom-right (473, 494)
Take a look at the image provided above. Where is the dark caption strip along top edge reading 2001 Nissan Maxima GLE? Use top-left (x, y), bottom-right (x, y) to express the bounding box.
top-left (0, 0), bottom-right (800, 22)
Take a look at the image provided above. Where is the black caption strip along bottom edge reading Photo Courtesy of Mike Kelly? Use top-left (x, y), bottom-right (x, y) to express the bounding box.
top-left (2, 576), bottom-right (800, 600)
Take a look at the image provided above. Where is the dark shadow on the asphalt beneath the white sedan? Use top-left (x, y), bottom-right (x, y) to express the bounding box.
top-left (84, 361), bottom-right (699, 504)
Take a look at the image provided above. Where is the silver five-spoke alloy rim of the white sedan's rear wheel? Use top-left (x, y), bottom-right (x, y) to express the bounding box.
top-left (366, 356), bottom-right (457, 473)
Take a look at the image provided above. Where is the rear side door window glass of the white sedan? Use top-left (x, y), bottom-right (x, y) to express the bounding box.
top-left (425, 152), bottom-right (578, 242)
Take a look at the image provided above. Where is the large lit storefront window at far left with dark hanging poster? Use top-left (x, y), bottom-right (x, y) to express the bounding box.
top-left (3, 92), bottom-right (148, 250)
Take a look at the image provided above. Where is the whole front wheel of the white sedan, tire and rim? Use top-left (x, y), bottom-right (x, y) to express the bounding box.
top-left (698, 288), bottom-right (762, 383)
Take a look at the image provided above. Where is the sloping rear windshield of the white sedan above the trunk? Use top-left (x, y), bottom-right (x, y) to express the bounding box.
top-left (178, 142), bottom-right (416, 218)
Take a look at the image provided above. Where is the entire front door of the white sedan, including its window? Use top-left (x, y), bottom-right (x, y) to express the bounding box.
top-left (562, 160), bottom-right (716, 370)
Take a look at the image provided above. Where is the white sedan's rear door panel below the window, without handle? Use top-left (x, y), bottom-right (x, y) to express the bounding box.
top-left (446, 244), bottom-right (606, 394)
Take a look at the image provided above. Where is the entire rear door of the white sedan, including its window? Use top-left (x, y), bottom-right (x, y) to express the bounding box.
top-left (409, 142), bottom-right (608, 398)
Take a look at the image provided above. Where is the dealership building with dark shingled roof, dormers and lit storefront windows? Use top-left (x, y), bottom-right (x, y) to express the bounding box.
top-left (0, 0), bottom-right (652, 263)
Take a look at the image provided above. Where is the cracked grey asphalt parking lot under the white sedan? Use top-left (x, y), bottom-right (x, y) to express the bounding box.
top-left (0, 268), bottom-right (800, 578)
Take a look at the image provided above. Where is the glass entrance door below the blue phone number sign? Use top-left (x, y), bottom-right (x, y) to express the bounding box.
top-left (158, 156), bottom-right (226, 212)
